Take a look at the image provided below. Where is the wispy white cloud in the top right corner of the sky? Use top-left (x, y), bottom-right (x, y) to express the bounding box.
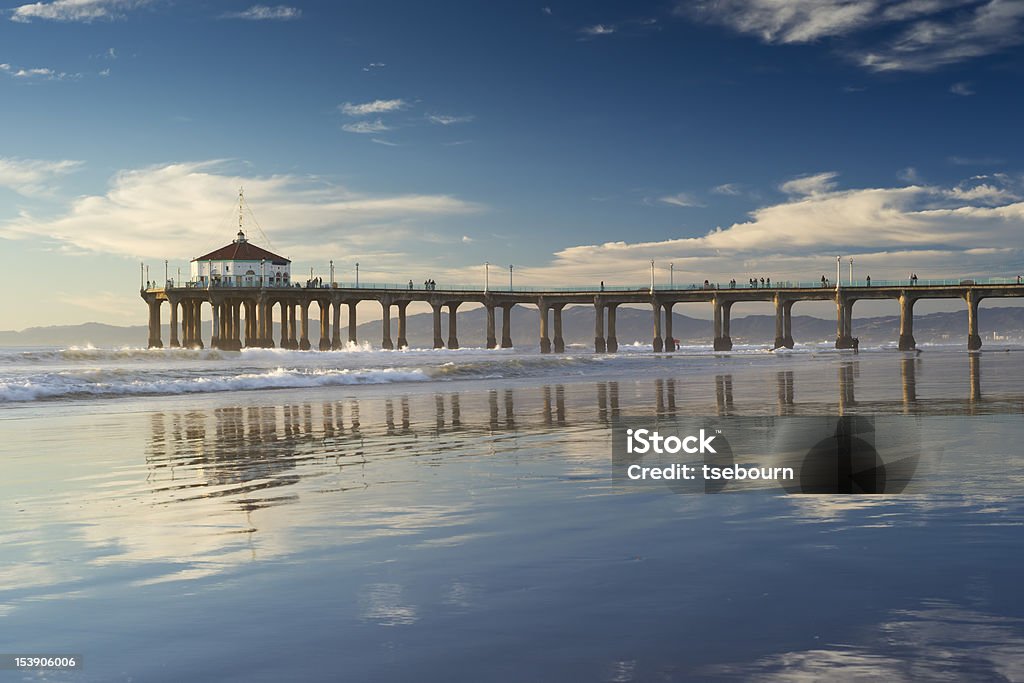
top-left (676, 0), bottom-right (1024, 71)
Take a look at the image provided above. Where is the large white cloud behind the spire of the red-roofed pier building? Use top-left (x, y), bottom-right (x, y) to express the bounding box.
top-left (0, 162), bottom-right (482, 263)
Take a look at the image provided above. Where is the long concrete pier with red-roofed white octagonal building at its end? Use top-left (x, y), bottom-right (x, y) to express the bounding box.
top-left (140, 228), bottom-right (1024, 353)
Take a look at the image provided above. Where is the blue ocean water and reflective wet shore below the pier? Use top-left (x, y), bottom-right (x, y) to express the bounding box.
top-left (0, 345), bottom-right (1024, 681)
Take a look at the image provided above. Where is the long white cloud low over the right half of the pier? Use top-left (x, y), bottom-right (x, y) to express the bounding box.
top-left (436, 174), bottom-right (1024, 285)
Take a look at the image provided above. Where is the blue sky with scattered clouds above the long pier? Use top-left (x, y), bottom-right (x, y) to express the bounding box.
top-left (0, 0), bottom-right (1024, 329)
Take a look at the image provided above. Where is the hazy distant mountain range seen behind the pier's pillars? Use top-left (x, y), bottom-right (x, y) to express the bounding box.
top-left (6, 306), bottom-right (1024, 348)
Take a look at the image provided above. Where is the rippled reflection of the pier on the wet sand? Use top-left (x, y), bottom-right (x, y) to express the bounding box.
top-left (147, 354), bottom-right (1024, 509)
